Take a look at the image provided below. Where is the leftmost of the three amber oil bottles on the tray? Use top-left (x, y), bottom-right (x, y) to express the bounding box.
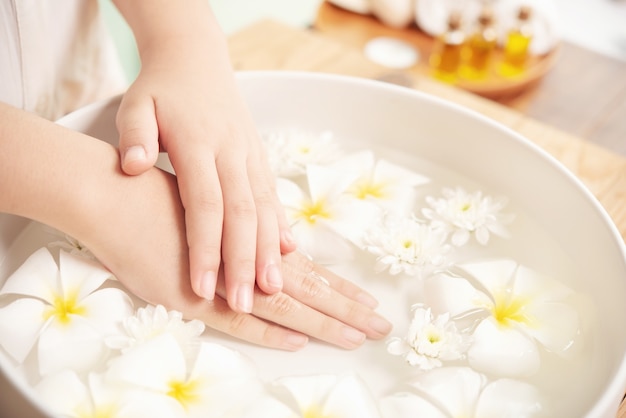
top-left (429, 12), bottom-right (465, 83)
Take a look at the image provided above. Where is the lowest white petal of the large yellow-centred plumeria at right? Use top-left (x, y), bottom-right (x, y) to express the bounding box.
top-left (467, 317), bottom-right (541, 377)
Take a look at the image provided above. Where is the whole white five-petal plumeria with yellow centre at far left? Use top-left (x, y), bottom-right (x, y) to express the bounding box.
top-left (0, 248), bottom-right (132, 375)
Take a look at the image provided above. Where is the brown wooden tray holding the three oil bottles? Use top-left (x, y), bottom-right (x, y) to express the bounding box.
top-left (314, 2), bottom-right (558, 99)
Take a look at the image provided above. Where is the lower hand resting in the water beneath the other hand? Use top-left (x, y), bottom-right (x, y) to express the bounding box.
top-left (88, 159), bottom-right (391, 350)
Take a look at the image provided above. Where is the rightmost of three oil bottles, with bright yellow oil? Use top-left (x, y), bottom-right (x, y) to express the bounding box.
top-left (500, 6), bottom-right (533, 76)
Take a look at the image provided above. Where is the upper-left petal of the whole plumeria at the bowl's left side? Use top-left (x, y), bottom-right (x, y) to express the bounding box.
top-left (0, 247), bottom-right (59, 303)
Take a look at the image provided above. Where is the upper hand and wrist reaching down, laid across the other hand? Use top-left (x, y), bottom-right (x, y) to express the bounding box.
top-left (109, 0), bottom-right (295, 313)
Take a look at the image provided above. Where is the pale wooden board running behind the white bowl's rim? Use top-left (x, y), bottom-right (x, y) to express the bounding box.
top-left (229, 15), bottom-right (626, 418)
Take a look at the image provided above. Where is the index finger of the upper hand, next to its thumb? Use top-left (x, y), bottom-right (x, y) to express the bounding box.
top-left (170, 155), bottom-right (224, 300)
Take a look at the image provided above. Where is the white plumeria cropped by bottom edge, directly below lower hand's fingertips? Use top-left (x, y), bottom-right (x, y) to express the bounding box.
top-left (276, 374), bottom-right (380, 418)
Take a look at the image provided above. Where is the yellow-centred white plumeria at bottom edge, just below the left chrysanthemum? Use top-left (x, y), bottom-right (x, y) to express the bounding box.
top-left (106, 334), bottom-right (262, 418)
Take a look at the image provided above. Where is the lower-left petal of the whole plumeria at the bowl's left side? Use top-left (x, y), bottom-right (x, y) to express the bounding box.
top-left (0, 298), bottom-right (46, 363)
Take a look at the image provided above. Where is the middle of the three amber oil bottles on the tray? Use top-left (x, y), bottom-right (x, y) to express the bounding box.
top-left (460, 7), bottom-right (498, 79)
